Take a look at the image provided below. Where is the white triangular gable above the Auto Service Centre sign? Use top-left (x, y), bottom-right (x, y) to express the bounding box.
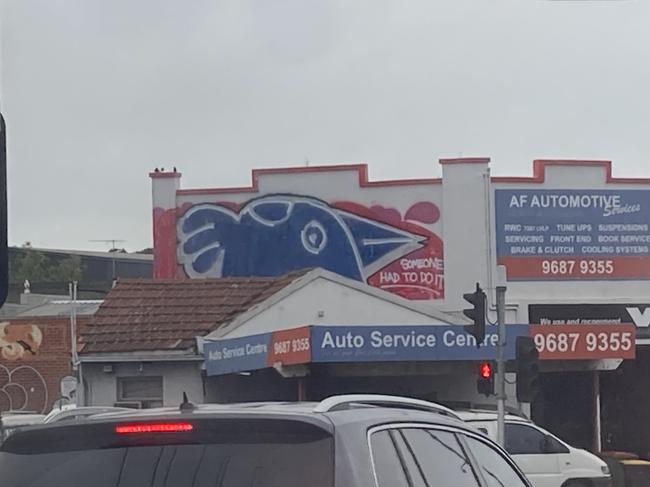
top-left (215, 278), bottom-right (454, 338)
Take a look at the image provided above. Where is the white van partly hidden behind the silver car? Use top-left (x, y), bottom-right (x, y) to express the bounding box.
top-left (456, 410), bottom-right (612, 487)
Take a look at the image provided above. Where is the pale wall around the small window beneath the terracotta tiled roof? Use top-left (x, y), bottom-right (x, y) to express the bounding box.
top-left (82, 362), bottom-right (204, 406)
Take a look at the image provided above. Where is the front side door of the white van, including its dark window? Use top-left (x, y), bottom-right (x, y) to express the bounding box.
top-left (505, 422), bottom-right (562, 487)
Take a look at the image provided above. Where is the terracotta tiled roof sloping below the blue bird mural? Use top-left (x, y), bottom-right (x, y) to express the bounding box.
top-left (82, 270), bottom-right (308, 354)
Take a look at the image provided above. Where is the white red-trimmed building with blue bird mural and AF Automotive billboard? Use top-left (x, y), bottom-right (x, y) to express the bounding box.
top-left (151, 158), bottom-right (650, 458)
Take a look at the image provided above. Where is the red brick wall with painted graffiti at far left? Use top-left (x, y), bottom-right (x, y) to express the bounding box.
top-left (0, 317), bottom-right (85, 413)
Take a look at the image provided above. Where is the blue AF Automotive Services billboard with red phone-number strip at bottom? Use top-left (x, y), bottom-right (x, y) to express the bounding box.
top-left (495, 189), bottom-right (650, 280)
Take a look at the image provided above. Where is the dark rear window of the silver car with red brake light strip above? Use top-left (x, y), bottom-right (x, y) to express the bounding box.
top-left (0, 419), bottom-right (334, 487)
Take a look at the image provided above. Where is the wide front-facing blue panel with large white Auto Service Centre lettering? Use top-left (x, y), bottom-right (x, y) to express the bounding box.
top-left (311, 325), bottom-right (528, 362)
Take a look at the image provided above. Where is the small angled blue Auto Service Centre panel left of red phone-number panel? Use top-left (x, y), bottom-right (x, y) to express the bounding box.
top-left (203, 333), bottom-right (273, 376)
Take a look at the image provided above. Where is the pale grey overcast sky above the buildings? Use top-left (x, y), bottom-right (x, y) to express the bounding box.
top-left (0, 0), bottom-right (650, 250)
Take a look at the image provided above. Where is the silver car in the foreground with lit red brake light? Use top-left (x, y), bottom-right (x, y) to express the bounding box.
top-left (0, 395), bottom-right (530, 487)
